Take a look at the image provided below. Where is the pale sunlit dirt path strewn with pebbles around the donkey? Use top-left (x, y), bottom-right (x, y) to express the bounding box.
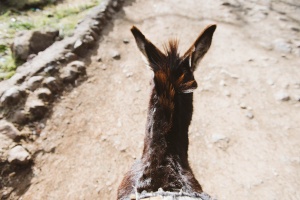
top-left (21, 0), bottom-right (300, 200)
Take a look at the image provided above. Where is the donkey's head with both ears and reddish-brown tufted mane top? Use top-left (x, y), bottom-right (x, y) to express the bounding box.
top-left (131, 25), bottom-right (216, 94)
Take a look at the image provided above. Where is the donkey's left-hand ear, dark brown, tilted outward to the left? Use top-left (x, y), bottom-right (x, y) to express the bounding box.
top-left (131, 26), bottom-right (165, 71)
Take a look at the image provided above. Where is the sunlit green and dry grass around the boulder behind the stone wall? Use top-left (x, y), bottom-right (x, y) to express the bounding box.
top-left (0, 0), bottom-right (100, 80)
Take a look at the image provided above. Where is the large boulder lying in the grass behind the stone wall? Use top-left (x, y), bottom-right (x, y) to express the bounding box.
top-left (11, 30), bottom-right (59, 61)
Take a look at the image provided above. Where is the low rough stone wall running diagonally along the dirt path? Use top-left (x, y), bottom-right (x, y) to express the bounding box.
top-left (0, 0), bottom-right (124, 166)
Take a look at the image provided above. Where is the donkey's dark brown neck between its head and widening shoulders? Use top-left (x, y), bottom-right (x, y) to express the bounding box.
top-left (143, 88), bottom-right (193, 162)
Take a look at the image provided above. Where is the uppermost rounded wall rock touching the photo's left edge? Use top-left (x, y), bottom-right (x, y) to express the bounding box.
top-left (0, 86), bottom-right (26, 106)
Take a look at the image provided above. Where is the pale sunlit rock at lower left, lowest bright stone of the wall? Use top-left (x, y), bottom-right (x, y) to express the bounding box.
top-left (8, 145), bottom-right (31, 165)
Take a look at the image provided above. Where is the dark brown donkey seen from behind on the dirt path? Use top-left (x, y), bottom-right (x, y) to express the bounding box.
top-left (118, 25), bottom-right (216, 200)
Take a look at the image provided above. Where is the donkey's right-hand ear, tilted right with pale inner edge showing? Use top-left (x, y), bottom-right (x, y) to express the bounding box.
top-left (184, 24), bottom-right (217, 71)
